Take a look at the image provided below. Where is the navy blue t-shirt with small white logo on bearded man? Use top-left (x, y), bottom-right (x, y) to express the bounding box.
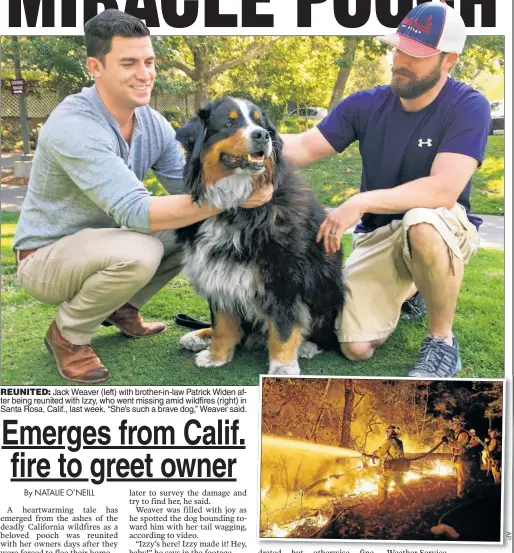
top-left (318, 78), bottom-right (491, 232)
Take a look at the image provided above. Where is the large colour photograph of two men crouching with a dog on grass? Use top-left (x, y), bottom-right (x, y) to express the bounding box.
top-left (1, 3), bottom-right (504, 385)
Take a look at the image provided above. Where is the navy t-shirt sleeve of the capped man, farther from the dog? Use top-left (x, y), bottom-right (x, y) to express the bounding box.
top-left (437, 91), bottom-right (491, 166)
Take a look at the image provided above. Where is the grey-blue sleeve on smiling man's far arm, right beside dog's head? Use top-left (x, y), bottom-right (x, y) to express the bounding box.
top-left (152, 114), bottom-right (185, 194)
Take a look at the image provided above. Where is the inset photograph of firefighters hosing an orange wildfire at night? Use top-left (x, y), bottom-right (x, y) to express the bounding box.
top-left (260, 377), bottom-right (504, 543)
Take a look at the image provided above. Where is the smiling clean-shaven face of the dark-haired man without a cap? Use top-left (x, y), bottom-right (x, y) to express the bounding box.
top-left (91, 36), bottom-right (155, 109)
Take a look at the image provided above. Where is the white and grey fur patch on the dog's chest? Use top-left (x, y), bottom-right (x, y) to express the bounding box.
top-left (184, 217), bottom-right (264, 316)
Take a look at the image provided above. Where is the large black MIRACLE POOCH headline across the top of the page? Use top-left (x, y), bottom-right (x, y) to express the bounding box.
top-left (8, 0), bottom-right (497, 29)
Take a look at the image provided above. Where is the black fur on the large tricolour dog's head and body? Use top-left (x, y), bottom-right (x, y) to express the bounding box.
top-left (173, 98), bottom-right (343, 368)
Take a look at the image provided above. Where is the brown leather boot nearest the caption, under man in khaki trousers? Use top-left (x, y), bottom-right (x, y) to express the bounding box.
top-left (45, 321), bottom-right (111, 384)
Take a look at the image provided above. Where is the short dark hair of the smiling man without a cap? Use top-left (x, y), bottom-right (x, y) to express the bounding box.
top-left (84, 8), bottom-right (150, 65)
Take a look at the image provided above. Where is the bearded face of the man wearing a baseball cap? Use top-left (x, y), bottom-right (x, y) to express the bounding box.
top-left (391, 49), bottom-right (444, 100)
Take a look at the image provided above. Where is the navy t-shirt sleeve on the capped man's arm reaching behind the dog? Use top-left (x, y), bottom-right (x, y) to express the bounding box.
top-left (318, 91), bottom-right (369, 152)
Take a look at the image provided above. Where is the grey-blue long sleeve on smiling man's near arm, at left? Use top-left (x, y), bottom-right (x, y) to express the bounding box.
top-left (45, 113), bottom-right (150, 233)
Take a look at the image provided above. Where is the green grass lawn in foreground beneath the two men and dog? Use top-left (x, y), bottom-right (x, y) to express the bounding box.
top-left (1, 209), bottom-right (504, 385)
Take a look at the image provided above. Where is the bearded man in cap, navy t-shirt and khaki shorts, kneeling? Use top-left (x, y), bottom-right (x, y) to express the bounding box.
top-left (285, 2), bottom-right (490, 378)
